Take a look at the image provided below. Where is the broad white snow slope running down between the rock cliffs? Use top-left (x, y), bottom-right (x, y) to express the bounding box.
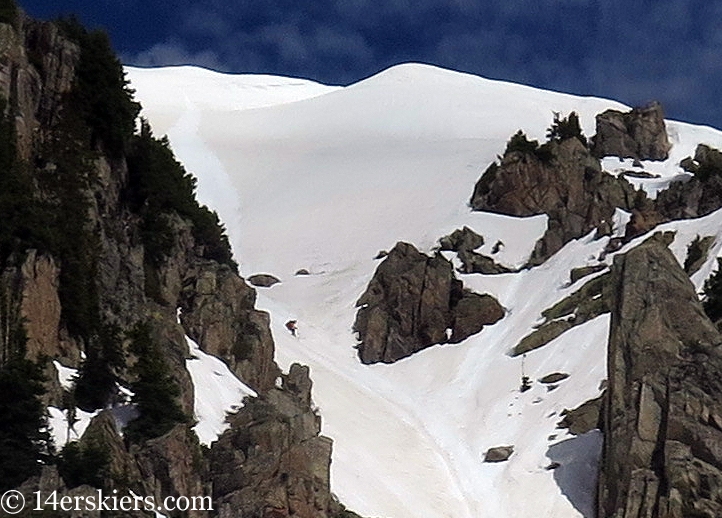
top-left (127, 64), bottom-right (722, 518)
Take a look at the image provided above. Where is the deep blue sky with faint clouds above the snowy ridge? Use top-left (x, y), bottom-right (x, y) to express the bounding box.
top-left (19, 0), bottom-right (722, 128)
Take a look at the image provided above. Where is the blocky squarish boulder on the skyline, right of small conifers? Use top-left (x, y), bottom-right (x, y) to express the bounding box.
top-left (593, 103), bottom-right (672, 160)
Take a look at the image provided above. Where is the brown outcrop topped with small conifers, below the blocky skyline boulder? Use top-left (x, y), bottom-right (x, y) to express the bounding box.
top-left (470, 138), bottom-right (635, 265)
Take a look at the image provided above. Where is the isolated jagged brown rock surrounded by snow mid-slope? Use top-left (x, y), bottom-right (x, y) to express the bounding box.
top-left (354, 243), bottom-right (504, 363)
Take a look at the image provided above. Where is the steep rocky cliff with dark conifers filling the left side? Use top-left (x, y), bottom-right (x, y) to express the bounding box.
top-left (0, 11), bottom-right (350, 518)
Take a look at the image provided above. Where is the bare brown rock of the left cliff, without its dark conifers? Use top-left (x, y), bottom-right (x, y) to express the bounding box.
top-left (0, 9), bottom-right (353, 518)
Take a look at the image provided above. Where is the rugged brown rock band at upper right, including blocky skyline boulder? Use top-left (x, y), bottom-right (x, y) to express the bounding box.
top-left (470, 103), bottom-right (722, 266)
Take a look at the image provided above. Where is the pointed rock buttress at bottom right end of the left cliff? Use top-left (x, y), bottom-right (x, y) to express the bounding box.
top-left (209, 364), bottom-right (343, 518)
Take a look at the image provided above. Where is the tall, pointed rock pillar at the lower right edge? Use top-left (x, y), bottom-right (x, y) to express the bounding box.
top-left (598, 236), bottom-right (722, 518)
